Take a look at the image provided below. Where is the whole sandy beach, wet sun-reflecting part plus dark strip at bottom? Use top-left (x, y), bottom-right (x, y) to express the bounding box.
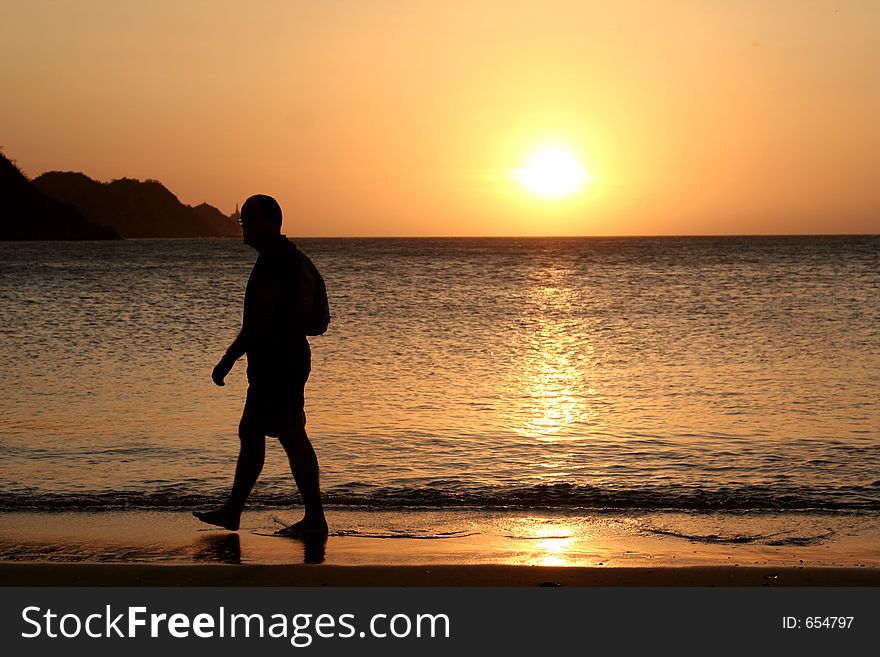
top-left (0, 510), bottom-right (880, 587)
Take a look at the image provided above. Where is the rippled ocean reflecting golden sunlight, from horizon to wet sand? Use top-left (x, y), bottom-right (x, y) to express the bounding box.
top-left (0, 237), bottom-right (880, 515)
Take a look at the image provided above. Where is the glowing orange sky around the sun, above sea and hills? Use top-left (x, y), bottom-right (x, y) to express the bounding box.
top-left (0, 0), bottom-right (880, 236)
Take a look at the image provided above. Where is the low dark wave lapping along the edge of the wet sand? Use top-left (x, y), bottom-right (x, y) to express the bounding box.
top-left (0, 481), bottom-right (880, 512)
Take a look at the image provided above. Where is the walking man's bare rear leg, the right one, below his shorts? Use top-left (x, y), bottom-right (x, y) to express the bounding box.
top-left (275, 412), bottom-right (327, 536)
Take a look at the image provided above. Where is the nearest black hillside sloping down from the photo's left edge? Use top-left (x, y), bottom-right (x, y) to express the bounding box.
top-left (0, 153), bottom-right (119, 240)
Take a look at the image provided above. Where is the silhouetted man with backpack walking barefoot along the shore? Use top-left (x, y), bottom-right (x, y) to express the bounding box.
top-left (193, 195), bottom-right (329, 538)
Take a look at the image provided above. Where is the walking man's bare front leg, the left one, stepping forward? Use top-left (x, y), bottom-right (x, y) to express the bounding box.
top-left (193, 403), bottom-right (266, 531)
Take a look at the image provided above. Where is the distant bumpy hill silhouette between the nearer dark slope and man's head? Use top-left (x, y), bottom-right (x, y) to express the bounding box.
top-left (33, 171), bottom-right (241, 237)
